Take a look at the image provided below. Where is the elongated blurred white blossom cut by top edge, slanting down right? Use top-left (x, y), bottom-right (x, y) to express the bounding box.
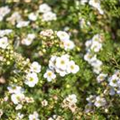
top-left (89, 0), bottom-right (104, 14)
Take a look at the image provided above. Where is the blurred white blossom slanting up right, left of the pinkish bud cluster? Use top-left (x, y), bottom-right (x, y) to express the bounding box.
top-left (21, 33), bottom-right (35, 46)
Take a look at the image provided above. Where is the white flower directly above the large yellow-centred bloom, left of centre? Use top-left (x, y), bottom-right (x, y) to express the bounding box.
top-left (30, 61), bottom-right (41, 73)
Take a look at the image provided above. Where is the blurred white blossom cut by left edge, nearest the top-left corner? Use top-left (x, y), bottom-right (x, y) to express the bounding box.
top-left (0, 6), bottom-right (11, 21)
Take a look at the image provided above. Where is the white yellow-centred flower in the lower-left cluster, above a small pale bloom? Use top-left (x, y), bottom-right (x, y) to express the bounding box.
top-left (11, 93), bottom-right (25, 104)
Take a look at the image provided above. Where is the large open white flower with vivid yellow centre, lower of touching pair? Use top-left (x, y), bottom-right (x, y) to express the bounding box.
top-left (25, 73), bottom-right (38, 87)
